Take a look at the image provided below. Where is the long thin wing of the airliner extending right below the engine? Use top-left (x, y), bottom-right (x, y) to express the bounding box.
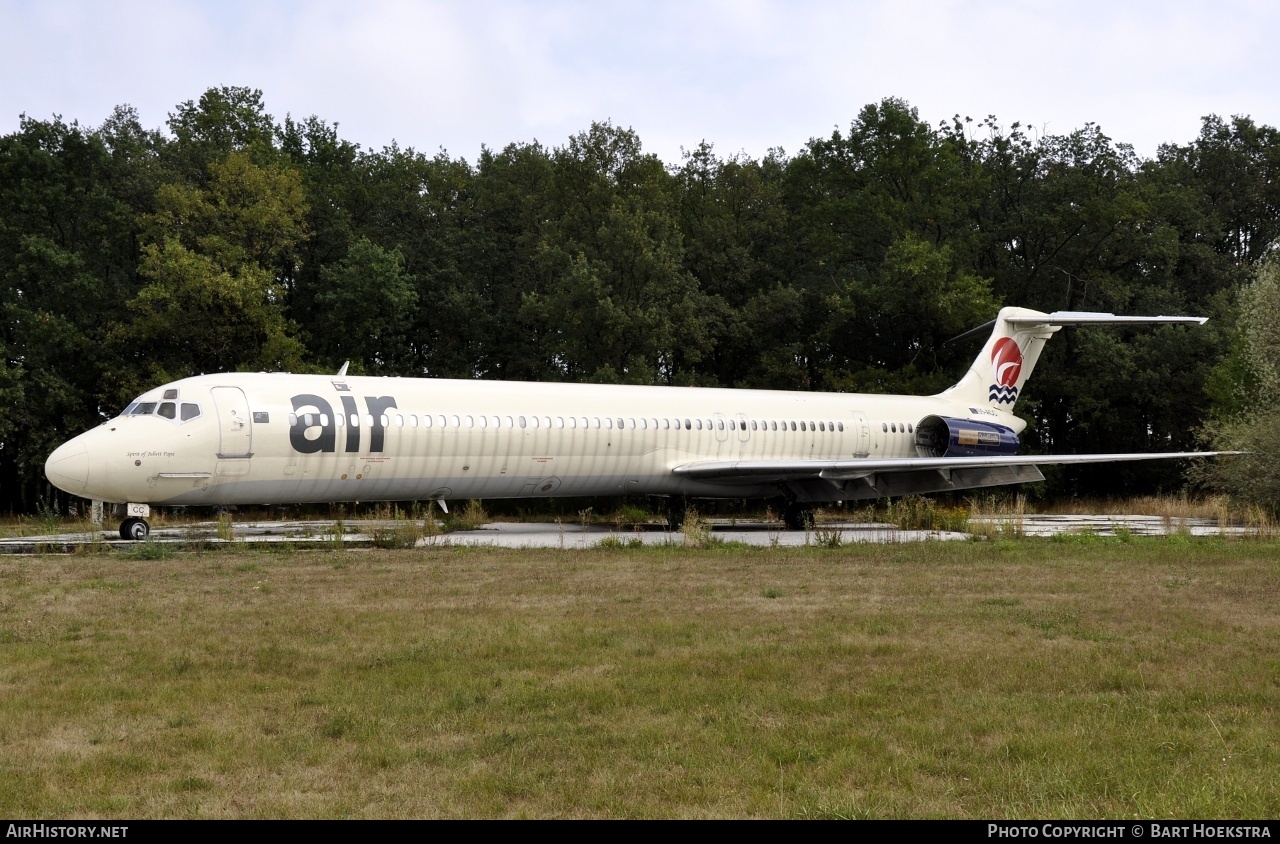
top-left (672, 451), bottom-right (1223, 483)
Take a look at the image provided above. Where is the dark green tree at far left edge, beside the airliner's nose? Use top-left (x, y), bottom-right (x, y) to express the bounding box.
top-left (0, 108), bottom-right (160, 508)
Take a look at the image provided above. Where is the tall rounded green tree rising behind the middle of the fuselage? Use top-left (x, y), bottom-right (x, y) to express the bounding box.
top-left (521, 123), bottom-right (716, 383)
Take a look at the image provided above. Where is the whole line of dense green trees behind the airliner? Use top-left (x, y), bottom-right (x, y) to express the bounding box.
top-left (0, 87), bottom-right (1280, 511)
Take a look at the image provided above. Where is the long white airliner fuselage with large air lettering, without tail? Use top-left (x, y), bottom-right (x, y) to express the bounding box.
top-left (46, 373), bottom-right (1024, 505)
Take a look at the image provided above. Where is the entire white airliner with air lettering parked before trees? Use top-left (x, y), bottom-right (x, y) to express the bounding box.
top-left (45, 307), bottom-right (1217, 539)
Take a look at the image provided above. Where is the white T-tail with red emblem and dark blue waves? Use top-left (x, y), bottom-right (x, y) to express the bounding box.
top-left (941, 307), bottom-right (1208, 411)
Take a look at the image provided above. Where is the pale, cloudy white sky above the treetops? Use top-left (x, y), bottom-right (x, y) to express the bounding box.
top-left (0, 0), bottom-right (1280, 163)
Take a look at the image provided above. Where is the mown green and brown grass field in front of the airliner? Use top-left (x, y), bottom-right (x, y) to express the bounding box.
top-left (0, 537), bottom-right (1280, 818)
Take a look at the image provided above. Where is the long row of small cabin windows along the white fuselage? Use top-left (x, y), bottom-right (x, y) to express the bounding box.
top-left (289, 414), bottom-right (845, 433)
